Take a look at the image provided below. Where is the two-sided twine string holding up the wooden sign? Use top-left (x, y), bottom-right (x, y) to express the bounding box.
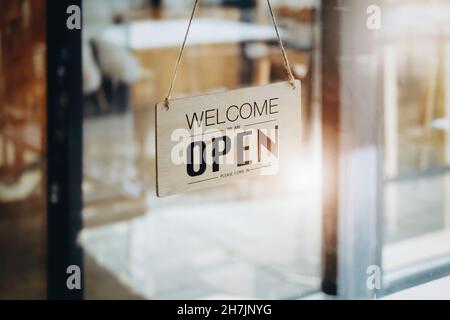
top-left (164, 0), bottom-right (295, 110)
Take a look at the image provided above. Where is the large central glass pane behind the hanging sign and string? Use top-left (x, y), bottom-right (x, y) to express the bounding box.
top-left (81, 0), bottom-right (321, 299)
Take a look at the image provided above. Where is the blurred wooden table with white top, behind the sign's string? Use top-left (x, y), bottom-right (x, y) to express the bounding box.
top-left (94, 18), bottom-right (282, 106)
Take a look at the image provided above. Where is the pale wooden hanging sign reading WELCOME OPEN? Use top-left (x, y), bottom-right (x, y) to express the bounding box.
top-left (156, 80), bottom-right (301, 197)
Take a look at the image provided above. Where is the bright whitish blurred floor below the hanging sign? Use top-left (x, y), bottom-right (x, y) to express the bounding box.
top-left (82, 192), bottom-right (320, 299)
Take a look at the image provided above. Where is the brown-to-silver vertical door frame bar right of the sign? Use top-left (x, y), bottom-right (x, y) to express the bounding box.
top-left (322, 0), bottom-right (383, 299)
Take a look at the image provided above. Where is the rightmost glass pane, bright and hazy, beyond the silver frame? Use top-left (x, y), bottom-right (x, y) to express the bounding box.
top-left (383, 1), bottom-right (450, 286)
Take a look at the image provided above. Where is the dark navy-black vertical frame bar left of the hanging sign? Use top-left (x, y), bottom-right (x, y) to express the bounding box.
top-left (46, 0), bottom-right (83, 299)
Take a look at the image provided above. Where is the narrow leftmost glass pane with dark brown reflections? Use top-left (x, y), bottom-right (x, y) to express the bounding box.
top-left (0, 0), bottom-right (47, 299)
